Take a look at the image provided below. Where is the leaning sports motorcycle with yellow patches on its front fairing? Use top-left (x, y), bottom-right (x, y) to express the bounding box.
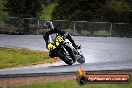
top-left (48, 33), bottom-right (85, 65)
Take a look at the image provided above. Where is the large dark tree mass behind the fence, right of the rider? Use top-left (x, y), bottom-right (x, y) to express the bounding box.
top-left (52, 0), bottom-right (132, 23)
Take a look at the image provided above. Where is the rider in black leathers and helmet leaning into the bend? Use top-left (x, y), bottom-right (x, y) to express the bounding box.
top-left (43, 21), bottom-right (80, 58)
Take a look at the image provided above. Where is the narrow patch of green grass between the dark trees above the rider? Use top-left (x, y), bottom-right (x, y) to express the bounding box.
top-left (41, 2), bottom-right (57, 20)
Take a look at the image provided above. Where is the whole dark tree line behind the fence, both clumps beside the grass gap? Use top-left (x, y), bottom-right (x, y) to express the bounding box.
top-left (3, 0), bottom-right (132, 23)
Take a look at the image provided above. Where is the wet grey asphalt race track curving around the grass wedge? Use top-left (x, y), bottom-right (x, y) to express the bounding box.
top-left (0, 35), bottom-right (132, 75)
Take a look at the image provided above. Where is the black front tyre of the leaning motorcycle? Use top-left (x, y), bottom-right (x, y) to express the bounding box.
top-left (58, 45), bottom-right (74, 65)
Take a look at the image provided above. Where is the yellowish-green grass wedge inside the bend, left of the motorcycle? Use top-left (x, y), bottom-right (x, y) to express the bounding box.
top-left (0, 47), bottom-right (58, 68)
